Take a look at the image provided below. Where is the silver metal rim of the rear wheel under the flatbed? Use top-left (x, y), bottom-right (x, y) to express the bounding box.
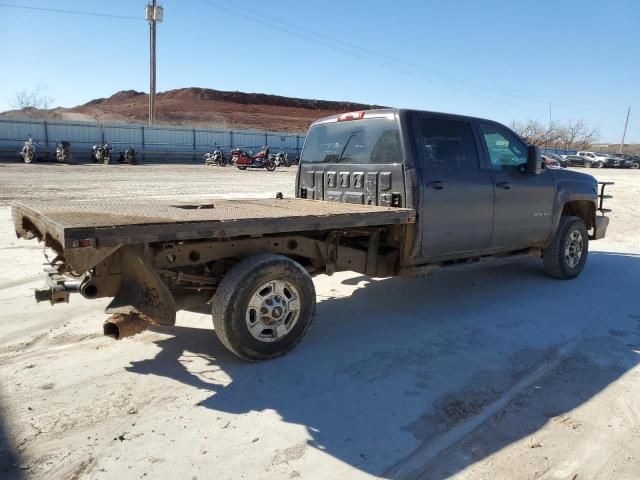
top-left (246, 280), bottom-right (300, 343)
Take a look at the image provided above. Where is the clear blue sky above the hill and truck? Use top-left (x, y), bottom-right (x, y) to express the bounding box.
top-left (0, 0), bottom-right (640, 142)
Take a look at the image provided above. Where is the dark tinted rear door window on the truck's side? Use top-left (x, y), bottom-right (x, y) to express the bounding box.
top-left (417, 118), bottom-right (479, 170)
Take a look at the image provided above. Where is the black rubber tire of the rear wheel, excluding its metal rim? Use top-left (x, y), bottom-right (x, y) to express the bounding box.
top-left (211, 254), bottom-right (316, 362)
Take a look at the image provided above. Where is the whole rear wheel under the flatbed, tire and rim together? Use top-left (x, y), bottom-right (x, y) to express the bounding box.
top-left (212, 254), bottom-right (316, 361)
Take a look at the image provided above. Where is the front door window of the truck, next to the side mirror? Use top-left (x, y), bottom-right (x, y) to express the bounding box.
top-left (480, 123), bottom-right (527, 170)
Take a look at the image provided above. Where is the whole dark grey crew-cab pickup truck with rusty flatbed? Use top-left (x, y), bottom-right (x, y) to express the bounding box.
top-left (12, 109), bottom-right (609, 361)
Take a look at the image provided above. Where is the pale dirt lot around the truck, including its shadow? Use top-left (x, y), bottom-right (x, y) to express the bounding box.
top-left (0, 164), bottom-right (640, 480)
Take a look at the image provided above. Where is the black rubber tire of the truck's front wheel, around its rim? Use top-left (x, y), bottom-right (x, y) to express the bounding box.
top-left (542, 216), bottom-right (589, 280)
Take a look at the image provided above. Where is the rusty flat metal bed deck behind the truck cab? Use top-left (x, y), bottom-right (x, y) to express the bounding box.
top-left (12, 198), bottom-right (415, 248)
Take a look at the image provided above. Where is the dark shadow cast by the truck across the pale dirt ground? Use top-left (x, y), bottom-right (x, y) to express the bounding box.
top-left (128, 252), bottom-right (640, 478)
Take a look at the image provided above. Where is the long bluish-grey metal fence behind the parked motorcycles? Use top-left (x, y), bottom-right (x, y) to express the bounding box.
top-left (0, 119), bottom-right (305, 163)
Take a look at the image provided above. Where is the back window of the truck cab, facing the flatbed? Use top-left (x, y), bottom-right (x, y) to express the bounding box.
top-left (301, 118), bottom-right (402, 163)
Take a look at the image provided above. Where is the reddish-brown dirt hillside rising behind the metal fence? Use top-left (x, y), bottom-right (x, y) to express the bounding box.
top-left (0, 88), bottom-right (384, 132)
